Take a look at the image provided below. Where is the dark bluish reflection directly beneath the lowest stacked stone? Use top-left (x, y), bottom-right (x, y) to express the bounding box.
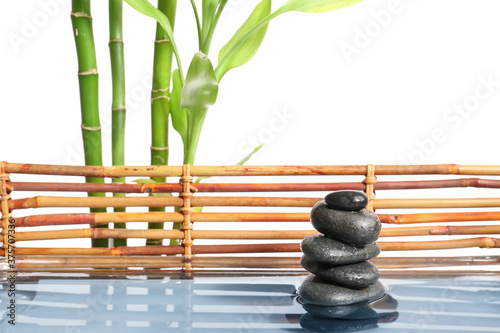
top-left (302, 302), bottom-right (378, 320)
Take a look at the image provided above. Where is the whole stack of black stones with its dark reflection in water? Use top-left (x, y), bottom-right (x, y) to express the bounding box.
top-left (298, 191), bottom-right (394, 331)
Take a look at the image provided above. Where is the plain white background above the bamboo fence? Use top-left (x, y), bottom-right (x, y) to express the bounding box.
top-left (0, 0), bottom-right (500, 256)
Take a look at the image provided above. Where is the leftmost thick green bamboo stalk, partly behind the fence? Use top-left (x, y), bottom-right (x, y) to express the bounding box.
top-left (71, 0), bottom-right (108, 247)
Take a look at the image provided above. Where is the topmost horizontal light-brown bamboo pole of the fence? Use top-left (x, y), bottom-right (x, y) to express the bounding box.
top-left (5, 163), bottom-right (500, 177)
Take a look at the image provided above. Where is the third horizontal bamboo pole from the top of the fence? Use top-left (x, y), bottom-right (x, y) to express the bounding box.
top-left (9, 196), bottom-right (500, 210)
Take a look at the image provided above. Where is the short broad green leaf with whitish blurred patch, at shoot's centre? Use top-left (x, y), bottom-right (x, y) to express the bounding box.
top-left (181, 52), bottom-right (219, 121)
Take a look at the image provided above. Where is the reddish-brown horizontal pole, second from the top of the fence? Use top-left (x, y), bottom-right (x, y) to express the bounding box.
top-left (8, 178), bottom-right (500, 193)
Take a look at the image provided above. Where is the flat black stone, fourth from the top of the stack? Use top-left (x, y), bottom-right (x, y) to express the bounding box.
top-left (300, 255), bottom-right (380, 289)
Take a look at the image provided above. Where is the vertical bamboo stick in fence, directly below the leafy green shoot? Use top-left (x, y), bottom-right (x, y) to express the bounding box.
top-left (179, 164), bottom-right (193, 274)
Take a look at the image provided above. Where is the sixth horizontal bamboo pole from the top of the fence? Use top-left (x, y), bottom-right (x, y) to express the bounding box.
top-left (0, 237), bottom-right (500, 256)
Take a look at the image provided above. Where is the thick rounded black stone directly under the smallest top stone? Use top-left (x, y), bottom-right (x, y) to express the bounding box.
top-left (311, 200), bottom-right (382, 246)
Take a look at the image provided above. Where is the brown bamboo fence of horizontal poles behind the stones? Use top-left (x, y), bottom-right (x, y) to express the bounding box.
top-left (0, 162), bottom-right (500, 269)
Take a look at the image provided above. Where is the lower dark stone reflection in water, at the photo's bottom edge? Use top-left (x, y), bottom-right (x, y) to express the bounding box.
top-left (300, 313), bottom-right (378, 333)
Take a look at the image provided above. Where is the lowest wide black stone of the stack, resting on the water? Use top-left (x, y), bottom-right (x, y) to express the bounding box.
top-left (298, 274), bottom-right (385, 306)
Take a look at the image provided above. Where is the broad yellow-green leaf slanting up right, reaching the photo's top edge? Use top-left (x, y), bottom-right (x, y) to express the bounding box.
top-left (217, 0), bottom-right (271, 81)
